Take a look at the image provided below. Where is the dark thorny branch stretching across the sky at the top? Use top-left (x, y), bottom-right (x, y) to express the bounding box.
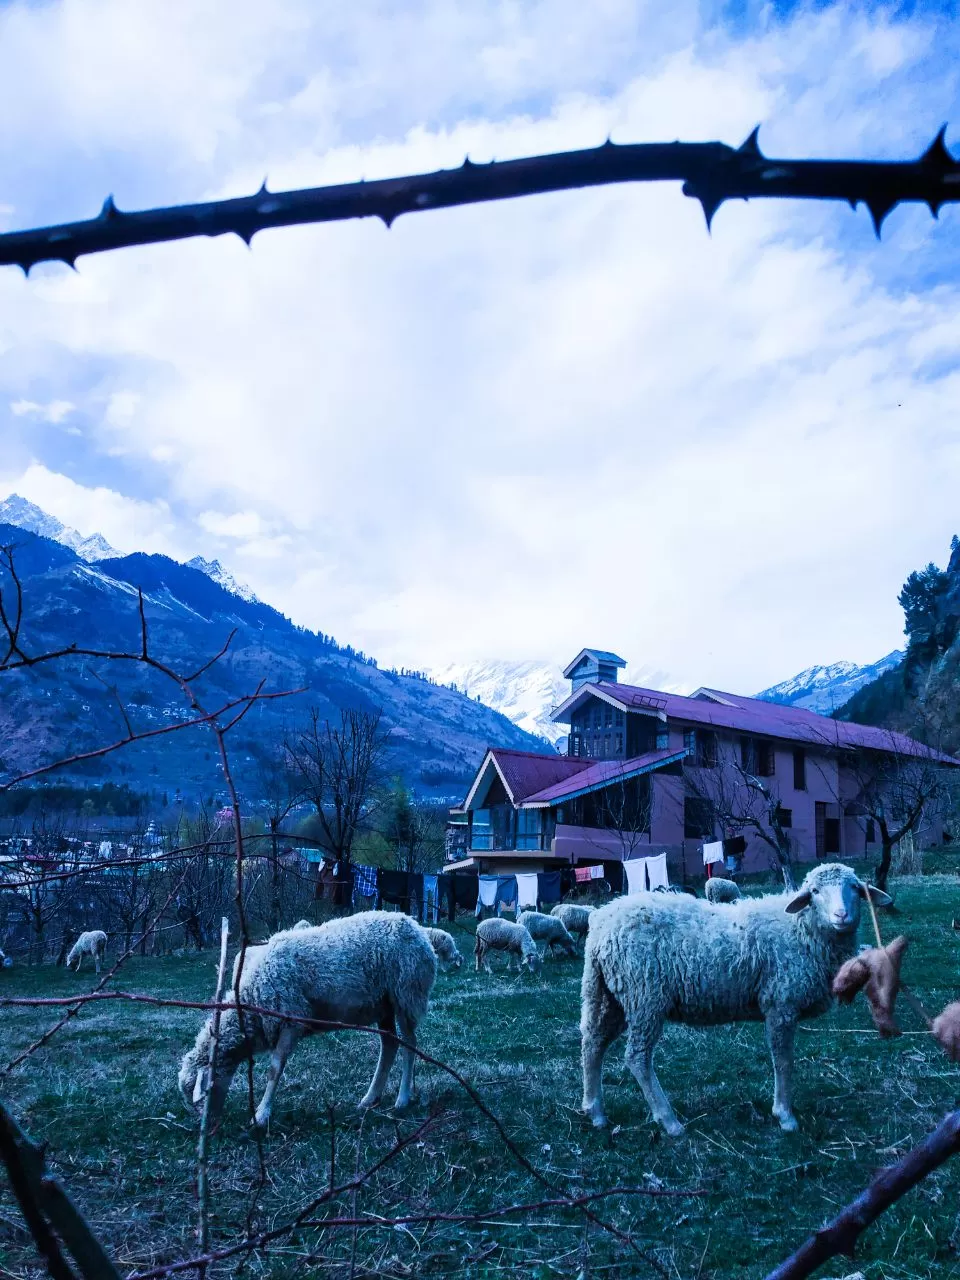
top-left (0, 125), bottom-right (960, 273)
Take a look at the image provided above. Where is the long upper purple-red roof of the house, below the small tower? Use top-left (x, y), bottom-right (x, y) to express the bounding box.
top-left (578, 682), bottom-right (960, 764)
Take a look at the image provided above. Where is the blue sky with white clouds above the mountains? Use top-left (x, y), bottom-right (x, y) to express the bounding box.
top-left (0, 0), bottom-right (960, 691)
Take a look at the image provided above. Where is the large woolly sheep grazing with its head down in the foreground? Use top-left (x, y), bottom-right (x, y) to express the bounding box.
top-left (178, 911), bottom-right (436, 1125)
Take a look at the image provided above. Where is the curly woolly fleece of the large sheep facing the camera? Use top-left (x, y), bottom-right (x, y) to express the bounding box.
top-left (584, 864), bottom-right (856, 1027)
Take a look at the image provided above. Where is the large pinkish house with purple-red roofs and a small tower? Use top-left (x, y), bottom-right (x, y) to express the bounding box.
top-left (452, 649), bottom-right (960, 883)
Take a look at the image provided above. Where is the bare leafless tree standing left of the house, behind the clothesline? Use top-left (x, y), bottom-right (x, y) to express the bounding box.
top-left (287, 708), bottom-right (387, 873)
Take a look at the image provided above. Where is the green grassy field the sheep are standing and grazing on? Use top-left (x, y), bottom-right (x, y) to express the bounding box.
top-left (0, 874), bottom-right (960, 1280)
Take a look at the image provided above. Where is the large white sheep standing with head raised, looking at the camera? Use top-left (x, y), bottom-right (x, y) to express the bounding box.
top-left (580, 863), bottom-right (891, 1135)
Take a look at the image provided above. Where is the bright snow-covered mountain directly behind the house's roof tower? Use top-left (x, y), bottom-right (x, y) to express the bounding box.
top-left (429, 659), bottom-right (689, 750)
